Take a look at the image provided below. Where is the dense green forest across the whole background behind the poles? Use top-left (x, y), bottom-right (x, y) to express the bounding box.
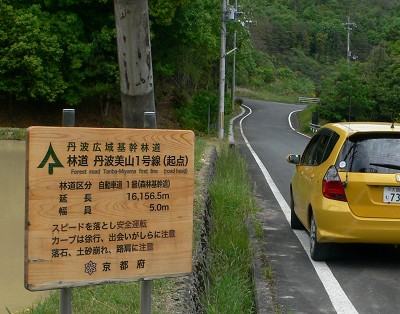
top-left (0, 0), bottom-right (400, 132)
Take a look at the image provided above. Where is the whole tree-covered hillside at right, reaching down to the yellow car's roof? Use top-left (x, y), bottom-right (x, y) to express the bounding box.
top-left (251, 0), bottom-right (400, 121)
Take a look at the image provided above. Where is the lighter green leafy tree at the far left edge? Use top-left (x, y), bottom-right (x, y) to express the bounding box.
top-left (0, 3), bottom-right (67, 108)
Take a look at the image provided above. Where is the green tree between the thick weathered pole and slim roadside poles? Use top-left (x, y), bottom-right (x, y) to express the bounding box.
top-left (152, 0), bottom-right (220, 91)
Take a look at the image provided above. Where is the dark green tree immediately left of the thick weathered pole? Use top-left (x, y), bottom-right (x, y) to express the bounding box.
top-left (43, 0), bottom-right (119, 105)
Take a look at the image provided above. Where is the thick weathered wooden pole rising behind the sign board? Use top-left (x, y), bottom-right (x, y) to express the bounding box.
top-left (114, 0), bottom-right (155, 128)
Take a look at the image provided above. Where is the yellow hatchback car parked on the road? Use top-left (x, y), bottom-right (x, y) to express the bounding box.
top-left (287, 122), bottom-right (400, 261)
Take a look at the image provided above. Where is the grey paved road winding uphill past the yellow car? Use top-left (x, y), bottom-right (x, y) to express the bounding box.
top-left (237, 99), bottom-right (400, 314)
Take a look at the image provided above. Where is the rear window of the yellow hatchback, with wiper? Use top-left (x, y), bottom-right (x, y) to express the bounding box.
top-left (336, 133), bottom-right (400, 173)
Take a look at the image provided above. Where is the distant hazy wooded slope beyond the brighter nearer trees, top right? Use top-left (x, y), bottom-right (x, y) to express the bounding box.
top-left (251, 0), bottom-right (400, 79)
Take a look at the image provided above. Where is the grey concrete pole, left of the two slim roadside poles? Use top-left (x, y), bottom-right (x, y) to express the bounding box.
top-left (218, 0), bottom-right (226, 139)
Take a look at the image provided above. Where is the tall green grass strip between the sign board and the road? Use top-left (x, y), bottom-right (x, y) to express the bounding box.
top-left (205, 146), bottom-right (255, 313)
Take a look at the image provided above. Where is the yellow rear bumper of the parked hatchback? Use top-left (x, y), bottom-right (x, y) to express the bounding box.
top-left (314, 200), bottom-right (400, 244)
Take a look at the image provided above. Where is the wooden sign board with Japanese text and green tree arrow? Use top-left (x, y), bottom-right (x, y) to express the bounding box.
top-left (25, 127), bottom-right (194, 291)
